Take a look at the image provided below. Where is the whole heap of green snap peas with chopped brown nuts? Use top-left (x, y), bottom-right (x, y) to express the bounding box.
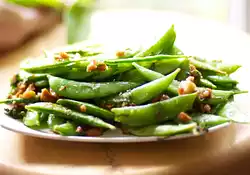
top-left (0, 25), bottom-right (249, 137)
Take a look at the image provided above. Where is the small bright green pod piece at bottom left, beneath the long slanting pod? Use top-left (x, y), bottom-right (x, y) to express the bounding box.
top-left (52, 121), bottom-right (78, 136)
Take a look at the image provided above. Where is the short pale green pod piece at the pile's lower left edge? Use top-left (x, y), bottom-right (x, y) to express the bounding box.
top-left (23, 111), bottom-right (40, 126)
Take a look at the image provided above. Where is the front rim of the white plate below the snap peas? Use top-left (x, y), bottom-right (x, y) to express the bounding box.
top-left (0, 114), bottom-right (232, 143)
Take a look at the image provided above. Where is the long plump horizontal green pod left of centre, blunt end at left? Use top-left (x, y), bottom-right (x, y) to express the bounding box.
top-left (48, 76), bottom-right (139, 100)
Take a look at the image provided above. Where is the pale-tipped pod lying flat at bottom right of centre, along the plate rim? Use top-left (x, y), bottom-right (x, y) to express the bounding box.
top-left (128, 123), bottom-right (197, 137)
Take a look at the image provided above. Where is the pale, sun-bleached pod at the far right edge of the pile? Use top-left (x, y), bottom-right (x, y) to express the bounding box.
top-left (218, 101), bottom-right (250, 123)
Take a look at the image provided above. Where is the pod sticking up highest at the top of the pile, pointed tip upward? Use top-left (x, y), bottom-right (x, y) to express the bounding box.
top-left (136, 25), bottom-right (176, 57)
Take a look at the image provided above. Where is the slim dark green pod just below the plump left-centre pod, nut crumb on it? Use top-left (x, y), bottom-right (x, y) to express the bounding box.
top-left (56, 99), bottom-right (114, 120)
